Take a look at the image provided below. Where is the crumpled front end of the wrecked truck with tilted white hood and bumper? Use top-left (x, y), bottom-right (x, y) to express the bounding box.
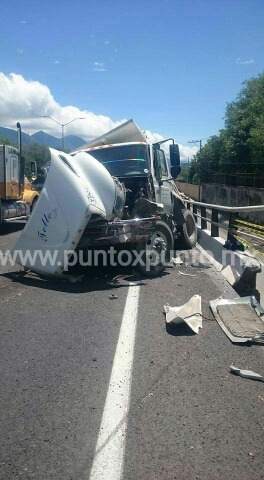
top-left (11, 149), bottom-right (164, 275)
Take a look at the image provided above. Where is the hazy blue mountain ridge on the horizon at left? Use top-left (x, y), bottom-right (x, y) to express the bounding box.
top-left (0, 127), bottom-right (85, 151)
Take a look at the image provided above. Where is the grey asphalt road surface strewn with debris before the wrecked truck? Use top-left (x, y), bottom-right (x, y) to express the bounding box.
top-left (0, 226), bottom-right (264, 480)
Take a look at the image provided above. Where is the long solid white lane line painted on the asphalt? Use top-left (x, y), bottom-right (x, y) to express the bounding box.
top-left (90, 286), bottom-right (140, 480)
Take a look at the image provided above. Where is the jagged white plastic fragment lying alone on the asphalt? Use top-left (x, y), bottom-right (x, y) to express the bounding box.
top-left (163, 295), bottom-right (202, 333)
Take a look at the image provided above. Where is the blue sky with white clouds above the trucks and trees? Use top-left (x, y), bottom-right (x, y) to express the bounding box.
top-left (0, 0), bottom-right (264, 158)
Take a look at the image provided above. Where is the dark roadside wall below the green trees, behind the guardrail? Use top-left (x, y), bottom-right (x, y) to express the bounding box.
top-left (201, 183), bottom-right (264, 225)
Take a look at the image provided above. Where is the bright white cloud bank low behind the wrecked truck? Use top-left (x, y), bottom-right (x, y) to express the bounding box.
top-left (0, 72), bottom-right (197, 160)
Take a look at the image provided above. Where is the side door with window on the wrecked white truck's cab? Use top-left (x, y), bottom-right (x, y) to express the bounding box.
top-left (154, 149), bottom-right (173, 214)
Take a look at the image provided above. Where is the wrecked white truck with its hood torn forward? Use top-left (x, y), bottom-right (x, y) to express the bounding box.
top-left (13, 120), bottom-right (197, 276)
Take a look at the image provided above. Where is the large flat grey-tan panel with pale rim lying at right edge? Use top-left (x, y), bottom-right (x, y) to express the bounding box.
top-left (210, 296), bottom-right (264, 343)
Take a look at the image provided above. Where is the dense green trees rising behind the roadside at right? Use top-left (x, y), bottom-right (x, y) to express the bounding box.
top-left (189, 73), bottom-right (264, 184)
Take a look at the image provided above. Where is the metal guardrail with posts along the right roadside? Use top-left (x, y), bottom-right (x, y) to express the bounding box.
top-left (186, 200), bottom-right (264, 246)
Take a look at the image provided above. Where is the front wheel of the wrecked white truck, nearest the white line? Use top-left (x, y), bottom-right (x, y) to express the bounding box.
top-left (135, 221), bottom-right (173, 277)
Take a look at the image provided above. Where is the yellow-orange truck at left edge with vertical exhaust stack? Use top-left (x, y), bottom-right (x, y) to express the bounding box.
top-left (0, 123), bottom-right (39, 229)
